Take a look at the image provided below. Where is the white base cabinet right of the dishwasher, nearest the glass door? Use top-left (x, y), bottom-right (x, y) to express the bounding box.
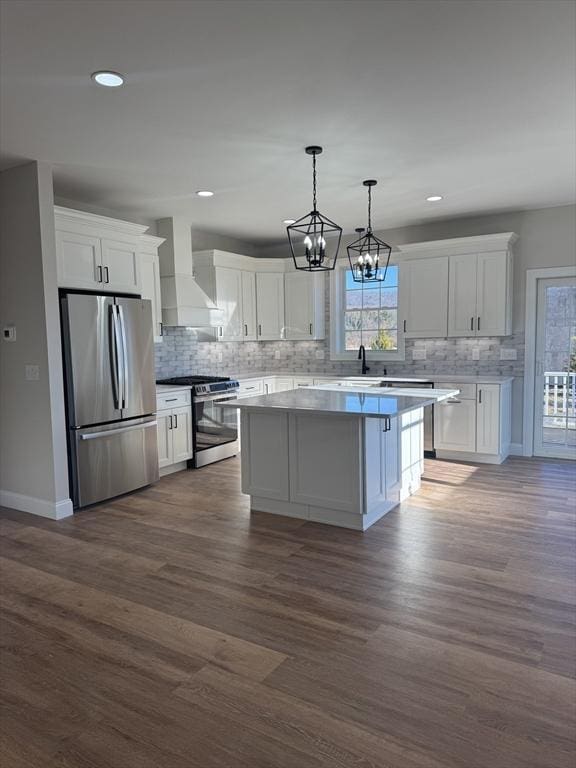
top-left (434, 382), bottom-right (511, 464)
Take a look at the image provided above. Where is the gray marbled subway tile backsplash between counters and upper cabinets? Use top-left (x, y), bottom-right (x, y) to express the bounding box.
top-left (155, 328), bottom-right (524, 379)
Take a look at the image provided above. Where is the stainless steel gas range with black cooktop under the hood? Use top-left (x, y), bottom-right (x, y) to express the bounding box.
top-left (157, 376), bottom-right (240, 467)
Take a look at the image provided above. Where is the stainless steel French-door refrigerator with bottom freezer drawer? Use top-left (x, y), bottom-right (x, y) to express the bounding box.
top-left (61, 293), bottom-right (158, 507)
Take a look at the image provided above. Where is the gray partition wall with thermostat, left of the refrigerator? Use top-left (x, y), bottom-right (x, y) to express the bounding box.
top-left (0, 162), bottom-right (72, 517)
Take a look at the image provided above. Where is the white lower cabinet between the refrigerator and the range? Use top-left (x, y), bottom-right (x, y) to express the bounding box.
top-left (156, 391), bottom-right (194, 474)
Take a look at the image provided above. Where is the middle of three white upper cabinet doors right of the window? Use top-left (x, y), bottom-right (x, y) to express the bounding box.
top-left (448, 253), bottom-right (477, 336)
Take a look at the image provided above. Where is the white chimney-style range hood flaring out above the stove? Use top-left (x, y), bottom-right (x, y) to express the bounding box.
top-left (156, 217), bottom-right (224, 328)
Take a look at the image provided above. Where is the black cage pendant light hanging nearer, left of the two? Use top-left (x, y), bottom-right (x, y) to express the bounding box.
top-left (286, 147), bottom-right (342, 272)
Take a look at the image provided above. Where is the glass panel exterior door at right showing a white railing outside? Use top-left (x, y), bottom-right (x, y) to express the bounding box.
top-left (534, 277), bottom-right (576, 459)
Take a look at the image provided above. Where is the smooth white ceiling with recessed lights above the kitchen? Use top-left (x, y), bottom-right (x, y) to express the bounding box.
top-left (1, 0), bottom-right (576, 243)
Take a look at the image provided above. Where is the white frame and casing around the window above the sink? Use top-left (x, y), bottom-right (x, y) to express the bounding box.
top-left (330, 259), bottom-right (406, 362)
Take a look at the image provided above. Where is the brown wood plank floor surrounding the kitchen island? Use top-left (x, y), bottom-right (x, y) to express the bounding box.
top-left (0, 459), bottom-right (576, 768)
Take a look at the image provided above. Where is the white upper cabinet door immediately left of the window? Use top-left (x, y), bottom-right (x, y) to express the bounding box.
top-left (284, 272), bottom-right (326, 341)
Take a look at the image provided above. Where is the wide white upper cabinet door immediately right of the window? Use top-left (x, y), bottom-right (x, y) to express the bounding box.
top-left (400, 256), bottom-right (448, 339)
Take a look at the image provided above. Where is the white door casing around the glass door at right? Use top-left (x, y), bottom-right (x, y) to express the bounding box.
top-left (522, 267), bottom-right (576, 456)
